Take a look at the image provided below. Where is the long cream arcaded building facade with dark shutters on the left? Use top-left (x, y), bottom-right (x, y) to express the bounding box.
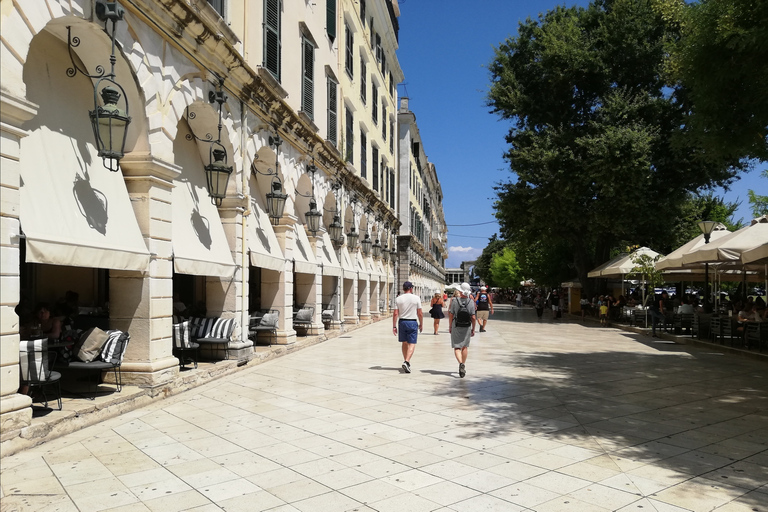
top-left (0, 0), bottom-right (420, 432)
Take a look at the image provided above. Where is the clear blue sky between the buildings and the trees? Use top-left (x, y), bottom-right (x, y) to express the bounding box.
top-left (397, 0), bottom-right (766, 268)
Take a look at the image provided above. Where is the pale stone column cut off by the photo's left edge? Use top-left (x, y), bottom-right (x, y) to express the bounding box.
top-left (0, 91), bottom-right (37, 441)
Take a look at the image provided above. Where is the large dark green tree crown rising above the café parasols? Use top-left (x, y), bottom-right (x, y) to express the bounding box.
top-left (488, 0), bottom-right (739, 292)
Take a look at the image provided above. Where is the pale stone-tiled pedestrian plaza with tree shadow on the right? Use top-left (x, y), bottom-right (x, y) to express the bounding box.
top-left (0, 308), bottom-right (768, 512)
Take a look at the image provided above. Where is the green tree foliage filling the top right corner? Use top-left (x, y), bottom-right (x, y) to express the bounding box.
top-left (655, 0), bottom-right (768, 160)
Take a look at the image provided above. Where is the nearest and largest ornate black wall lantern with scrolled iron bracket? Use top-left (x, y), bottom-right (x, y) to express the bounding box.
top-left (67, 0), bottom-right (131, 172)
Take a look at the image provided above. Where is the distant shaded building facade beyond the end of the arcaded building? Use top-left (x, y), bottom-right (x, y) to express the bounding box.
top-left (397, 97), bottom-right (448, 301)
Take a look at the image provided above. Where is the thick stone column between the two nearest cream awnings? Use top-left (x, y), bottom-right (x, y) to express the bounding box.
top-left (114, 154), bottom-right (181, 394)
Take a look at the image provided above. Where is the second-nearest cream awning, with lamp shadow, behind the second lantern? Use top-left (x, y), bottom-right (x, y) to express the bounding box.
top-left (171, 123), bottom-right (235, 277)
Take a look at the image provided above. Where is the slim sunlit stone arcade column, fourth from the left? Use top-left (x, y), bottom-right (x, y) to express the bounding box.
top-left (270, 222), bottom-right (296, 345)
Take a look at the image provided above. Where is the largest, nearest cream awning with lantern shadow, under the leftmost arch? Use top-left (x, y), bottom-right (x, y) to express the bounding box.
top-left (19, 126), bottom-right (149, 271)
